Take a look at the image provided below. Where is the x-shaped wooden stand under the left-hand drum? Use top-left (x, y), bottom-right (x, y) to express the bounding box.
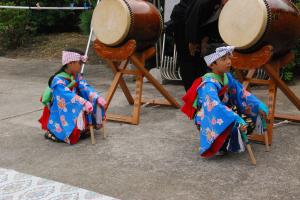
top-left (94, 40), bottom-right (180, 125)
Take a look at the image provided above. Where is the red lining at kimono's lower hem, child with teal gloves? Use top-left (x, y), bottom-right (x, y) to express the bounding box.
top-left (201, 124), bottom-right (233, 158)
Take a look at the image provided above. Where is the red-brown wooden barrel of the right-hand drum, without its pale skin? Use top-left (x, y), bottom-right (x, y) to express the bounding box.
top-left (220, 0), bottom-right (300, 56)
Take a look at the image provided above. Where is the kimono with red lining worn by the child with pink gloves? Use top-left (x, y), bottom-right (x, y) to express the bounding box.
top-left (40, 72), bottom-right (105, 144)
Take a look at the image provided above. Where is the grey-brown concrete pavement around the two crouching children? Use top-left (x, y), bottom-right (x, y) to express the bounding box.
top-left (0, 58), bottom-right (300, 200)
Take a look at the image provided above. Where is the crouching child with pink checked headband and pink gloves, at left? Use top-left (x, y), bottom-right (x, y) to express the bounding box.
top-left (39, 50), bottom-right (106, 144)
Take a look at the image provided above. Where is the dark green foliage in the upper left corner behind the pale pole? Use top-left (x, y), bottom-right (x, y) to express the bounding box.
top-left (0, 0), bottom-right (92, 51)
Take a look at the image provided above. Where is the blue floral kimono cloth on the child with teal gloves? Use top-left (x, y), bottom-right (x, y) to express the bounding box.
top-left (194, 73), bottom-right (261, 154)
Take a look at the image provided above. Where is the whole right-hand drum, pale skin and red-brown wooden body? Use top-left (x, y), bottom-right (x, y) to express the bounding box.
top-left (219, 0), bottom-right (300, 55)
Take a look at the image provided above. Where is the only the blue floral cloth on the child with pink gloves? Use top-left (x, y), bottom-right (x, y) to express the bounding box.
top-left (48, 76), bottom-right (104, 141)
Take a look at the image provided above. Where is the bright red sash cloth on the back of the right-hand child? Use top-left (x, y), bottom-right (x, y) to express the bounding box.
top-left (181, 77), bottom-right (202, 119)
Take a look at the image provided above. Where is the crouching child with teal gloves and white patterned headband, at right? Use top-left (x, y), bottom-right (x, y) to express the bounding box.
top-left (182, 44), bottom-right (268, 158)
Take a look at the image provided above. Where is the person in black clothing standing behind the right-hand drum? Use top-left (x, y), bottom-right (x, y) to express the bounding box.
top-left (171, 0), bottom-right (228, 91)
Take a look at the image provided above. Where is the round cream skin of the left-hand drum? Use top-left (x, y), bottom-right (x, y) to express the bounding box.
top-left (92, 0), bottom-right (131, 46)
